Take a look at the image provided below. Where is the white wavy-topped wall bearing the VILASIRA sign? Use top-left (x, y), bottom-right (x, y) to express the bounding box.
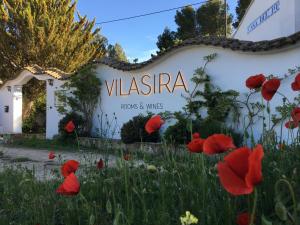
top-left (94, 45), bottom-right (300, 141)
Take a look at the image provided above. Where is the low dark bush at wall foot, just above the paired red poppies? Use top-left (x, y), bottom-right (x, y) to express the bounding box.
top-left (164, 114), bottom-right (243, 146)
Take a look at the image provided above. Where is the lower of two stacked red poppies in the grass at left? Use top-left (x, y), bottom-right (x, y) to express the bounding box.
top-left (56, 173), bottom-right (80, 195)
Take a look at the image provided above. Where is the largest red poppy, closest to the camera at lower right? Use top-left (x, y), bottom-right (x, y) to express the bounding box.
top-left (218, 145), bottom-right (264, 195)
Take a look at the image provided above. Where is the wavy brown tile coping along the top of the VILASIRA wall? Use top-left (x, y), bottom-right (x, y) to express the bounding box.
top-left (94, 32), bottom-right (300, 71)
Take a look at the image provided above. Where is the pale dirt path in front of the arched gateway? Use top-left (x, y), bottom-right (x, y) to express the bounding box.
top-left (0, 144), bottom-right (143, 180)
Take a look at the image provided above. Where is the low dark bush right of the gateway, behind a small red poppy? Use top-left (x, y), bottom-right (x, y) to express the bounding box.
top-left (58, 112), bottom-right (87, 140)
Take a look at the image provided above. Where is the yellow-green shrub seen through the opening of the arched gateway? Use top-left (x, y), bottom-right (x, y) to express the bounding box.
top-left (22, 93), bottom-right (46, 133)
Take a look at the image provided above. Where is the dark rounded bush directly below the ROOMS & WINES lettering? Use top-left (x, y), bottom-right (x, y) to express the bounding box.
top-left (121, 114), bottom-right (160, 144)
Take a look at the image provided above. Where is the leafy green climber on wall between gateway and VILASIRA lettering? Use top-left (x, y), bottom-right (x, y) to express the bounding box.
top-left (58, 65), bottom-right (101, 135)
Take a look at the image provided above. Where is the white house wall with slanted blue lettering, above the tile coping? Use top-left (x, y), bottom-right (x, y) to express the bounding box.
top-left (233, 0), bottom-right (300, 41)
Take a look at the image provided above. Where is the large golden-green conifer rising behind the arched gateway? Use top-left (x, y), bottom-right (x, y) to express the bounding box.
top-left (0, 0), bottom-right (103, 80)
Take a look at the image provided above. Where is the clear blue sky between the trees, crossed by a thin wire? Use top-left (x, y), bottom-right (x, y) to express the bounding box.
top-left (77, 0), bottom-right (237, 62)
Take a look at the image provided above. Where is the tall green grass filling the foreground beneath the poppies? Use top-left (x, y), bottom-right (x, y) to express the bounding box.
top-left (0, 148), bottom-right (300, 225)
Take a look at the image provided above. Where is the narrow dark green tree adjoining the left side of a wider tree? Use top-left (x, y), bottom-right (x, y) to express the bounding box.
top-left (175, 6), bottom-right (198, 40)
